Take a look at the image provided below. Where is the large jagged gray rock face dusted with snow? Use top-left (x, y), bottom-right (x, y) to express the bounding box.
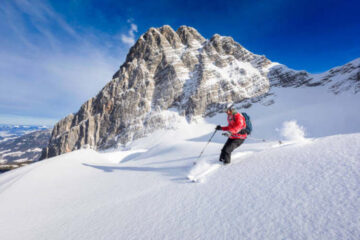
top-left (42, 26), bottom-right (360, 158)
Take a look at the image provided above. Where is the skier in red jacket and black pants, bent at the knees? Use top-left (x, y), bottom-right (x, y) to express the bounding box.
top-left (215, 105), bottom-right (247, 164)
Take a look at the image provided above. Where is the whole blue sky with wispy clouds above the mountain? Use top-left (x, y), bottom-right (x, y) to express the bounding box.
top-left (0, 0), bottom-right (360, 125)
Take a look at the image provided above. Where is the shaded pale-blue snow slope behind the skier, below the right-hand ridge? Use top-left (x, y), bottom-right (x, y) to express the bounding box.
top-left (242, 83), bottom-right (360, 139)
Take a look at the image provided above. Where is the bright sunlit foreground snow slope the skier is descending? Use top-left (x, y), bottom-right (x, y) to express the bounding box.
top-left (0, 116), bottom-right (360, 240)
